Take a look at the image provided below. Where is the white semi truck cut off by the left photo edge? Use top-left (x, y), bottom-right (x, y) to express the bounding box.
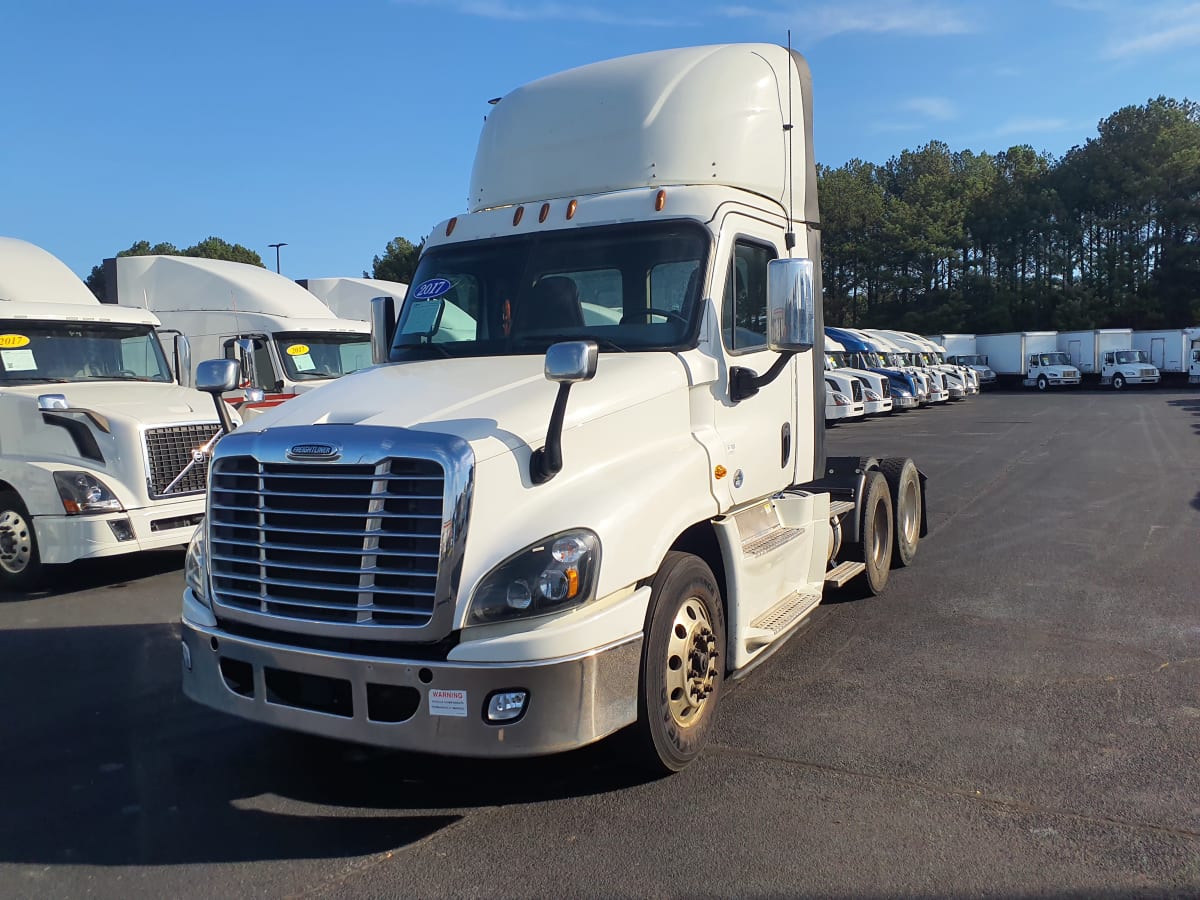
top-left (0, 238), bottom-right (229, 596)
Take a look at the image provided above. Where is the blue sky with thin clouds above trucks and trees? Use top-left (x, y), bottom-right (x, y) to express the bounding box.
top-left (0, 0), bottom-right (1200, 278)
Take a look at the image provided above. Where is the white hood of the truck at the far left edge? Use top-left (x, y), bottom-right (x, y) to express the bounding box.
top-left (0, 382), bottom-right (217, 425)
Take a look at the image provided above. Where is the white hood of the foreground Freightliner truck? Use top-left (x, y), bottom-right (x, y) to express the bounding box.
top-left (235, 352), bottom-right (688, 462)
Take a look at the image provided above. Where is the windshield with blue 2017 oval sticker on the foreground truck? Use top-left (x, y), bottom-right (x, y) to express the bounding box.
top-left (391, 222), bottom-right (709, 360)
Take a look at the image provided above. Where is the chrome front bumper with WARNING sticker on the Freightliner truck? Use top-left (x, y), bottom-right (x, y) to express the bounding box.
top-left (182, 617), bottom-right (642, 757)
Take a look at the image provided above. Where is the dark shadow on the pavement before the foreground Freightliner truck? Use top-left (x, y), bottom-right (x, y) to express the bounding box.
top-left (0, 624), bottom-right (647, 866)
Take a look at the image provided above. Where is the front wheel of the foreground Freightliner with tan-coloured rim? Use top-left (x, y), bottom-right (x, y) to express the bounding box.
top-left (635, 552), bottom-right (725, 774)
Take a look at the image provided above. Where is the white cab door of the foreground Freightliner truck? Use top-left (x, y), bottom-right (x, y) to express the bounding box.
top-left (713, 214), bottom-right (796, 505)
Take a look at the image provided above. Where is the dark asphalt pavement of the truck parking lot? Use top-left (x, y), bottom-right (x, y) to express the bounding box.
top-left (0, 389), bottom-right (1200, 898)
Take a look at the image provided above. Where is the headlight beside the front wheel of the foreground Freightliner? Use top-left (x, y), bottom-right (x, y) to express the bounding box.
top-left (467, 528), bottom-right (600, 625)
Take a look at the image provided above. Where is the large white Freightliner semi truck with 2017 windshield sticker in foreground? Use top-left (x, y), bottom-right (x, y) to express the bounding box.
top-left (182, 44), bottom-right (925, 770)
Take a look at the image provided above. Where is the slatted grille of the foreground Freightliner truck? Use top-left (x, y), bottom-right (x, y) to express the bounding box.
top-left (209, 456), bottom-right (445, 626)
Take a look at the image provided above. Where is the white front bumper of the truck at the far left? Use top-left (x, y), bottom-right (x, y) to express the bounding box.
top-left (34, 494), bottom-right (204, 565)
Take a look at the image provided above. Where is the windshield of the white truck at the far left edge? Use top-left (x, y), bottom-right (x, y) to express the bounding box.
top-left (0, 319), bottom-right (173, 384)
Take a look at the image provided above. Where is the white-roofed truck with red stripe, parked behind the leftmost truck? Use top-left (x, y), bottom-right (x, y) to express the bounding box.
top-left (115, 256), bottom-right (371, 415)
